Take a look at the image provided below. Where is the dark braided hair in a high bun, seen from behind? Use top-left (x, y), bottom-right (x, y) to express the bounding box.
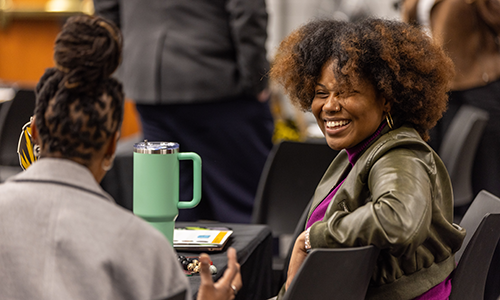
top-left (35, 15), bottom-right (124, 165)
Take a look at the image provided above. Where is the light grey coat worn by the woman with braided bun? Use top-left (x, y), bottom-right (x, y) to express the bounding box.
top-left (0, 158), bottom-right (191, 300)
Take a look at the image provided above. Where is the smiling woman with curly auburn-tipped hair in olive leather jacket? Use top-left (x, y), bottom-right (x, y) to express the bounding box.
top-left (271, 19), bottom-right (465, 300)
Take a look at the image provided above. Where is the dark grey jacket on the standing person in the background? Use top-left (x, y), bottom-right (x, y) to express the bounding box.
top-left (94, 0), bottom-right (269, 104)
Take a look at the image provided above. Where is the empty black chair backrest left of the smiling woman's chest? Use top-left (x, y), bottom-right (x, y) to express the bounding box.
top-left (252, 141), bottom-right (338, 236)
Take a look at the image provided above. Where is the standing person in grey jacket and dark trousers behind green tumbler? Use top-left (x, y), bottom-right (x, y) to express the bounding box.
top-left (94, 0), bottom-right (274, 223)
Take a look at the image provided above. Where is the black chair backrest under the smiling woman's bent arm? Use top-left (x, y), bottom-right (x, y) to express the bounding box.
top-left (284, 246), bottom-right (379, 300)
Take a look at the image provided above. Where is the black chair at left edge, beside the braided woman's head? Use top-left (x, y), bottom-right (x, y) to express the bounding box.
top-left (0, 89), bottom-right (36, 182)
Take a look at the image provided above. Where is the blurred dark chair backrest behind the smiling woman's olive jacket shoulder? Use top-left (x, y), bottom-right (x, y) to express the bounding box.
top-left (439, 105), bottom-right (489, 206)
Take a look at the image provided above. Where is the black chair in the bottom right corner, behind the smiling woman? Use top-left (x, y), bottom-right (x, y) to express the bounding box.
top-left (450, 190), bottom-right (500, 300)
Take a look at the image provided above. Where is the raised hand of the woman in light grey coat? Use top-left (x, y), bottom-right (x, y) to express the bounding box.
top-left (197, 248), bottom-right (243, 300)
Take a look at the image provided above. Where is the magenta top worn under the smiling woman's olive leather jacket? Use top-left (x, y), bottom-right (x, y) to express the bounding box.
top-left (306, 122), bottom-right (451, 300)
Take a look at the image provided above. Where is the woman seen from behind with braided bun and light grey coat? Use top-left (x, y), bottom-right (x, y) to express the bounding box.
top-left (0, 16), bottom-right (241, 300)
